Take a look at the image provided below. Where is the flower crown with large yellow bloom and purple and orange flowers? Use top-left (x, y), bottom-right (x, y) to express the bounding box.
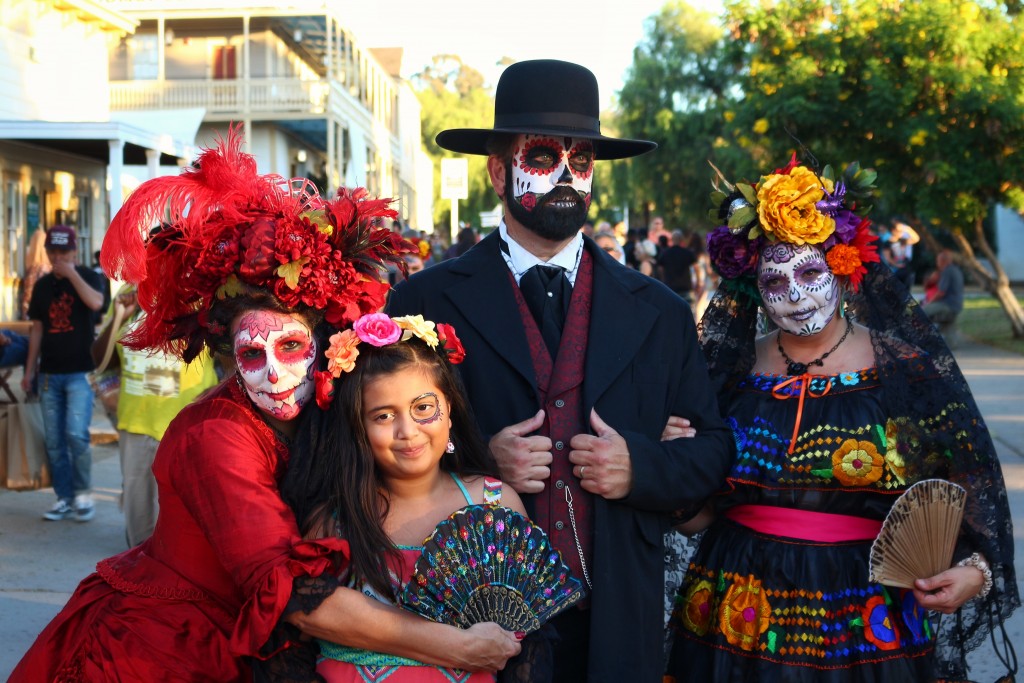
top-left (708, 154), bottom-right (879, 292)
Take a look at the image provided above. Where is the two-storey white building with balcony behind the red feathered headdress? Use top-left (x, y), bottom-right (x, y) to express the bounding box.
top-left (105, 0), bottom-right (433, 229)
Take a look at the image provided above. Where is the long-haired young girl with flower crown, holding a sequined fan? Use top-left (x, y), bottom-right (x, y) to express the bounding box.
top-left (286, 313), bottom-right (525, 682)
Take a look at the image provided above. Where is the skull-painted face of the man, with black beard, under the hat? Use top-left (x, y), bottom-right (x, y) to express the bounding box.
top-left (505, 133), bottom-right (594, 240)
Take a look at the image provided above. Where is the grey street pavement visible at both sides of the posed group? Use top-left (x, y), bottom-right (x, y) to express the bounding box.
top-left (0, 340), bottom-right (1024, 682)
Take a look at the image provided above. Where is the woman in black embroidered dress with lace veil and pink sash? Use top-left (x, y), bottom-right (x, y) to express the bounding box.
top-left (669, 156), bottom-right (1020, 682)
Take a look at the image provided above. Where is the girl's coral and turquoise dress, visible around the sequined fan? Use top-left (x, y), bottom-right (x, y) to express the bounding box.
top-left (316, 474), bottom-right (502, 683)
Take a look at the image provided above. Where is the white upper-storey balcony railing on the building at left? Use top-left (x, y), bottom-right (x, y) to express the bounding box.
top-left (111, 79), bottom-right (330, 116)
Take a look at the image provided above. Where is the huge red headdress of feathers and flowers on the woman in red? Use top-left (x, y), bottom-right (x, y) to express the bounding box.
top-left (100, 128), bottom-right (414, 360)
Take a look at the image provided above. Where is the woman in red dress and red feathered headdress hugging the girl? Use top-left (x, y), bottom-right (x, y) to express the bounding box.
top-left (10, 130), bottom-right (519, 683)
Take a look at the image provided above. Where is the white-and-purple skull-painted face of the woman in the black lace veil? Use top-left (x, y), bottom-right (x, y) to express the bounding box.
top-left (758, 244), bottom-right (839, 336)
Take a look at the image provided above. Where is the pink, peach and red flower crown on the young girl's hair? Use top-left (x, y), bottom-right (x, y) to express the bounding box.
top-left (314, 313), bottom-right (466, 410)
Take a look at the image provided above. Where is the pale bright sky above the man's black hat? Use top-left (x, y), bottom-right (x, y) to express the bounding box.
top-left (338, 0), bottom-right (720, 108)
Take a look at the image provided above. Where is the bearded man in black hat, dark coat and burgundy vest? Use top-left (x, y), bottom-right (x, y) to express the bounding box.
top-left (389, 60), bottom-right (732, 683)
